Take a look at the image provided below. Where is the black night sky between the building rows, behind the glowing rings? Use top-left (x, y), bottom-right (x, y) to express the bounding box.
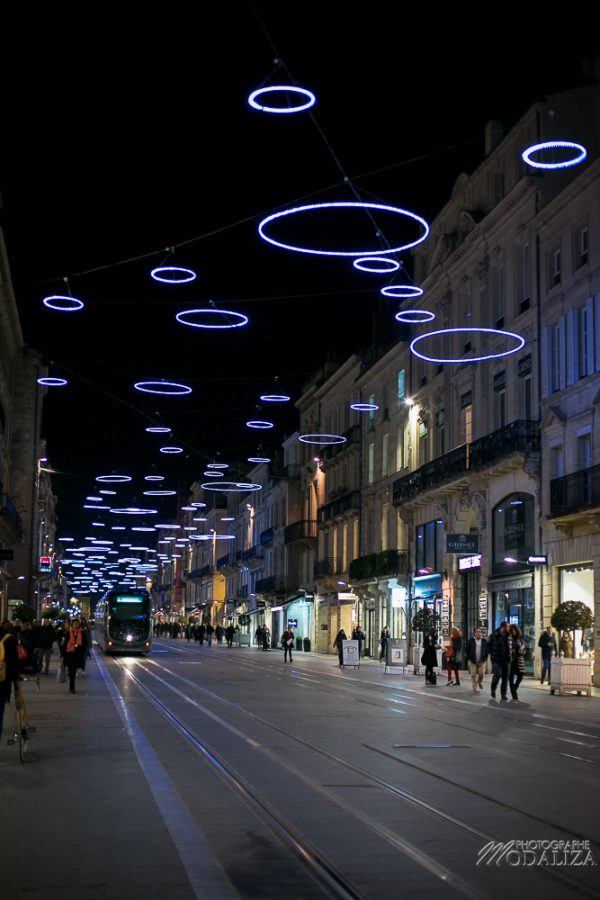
top-left (0, 7), bottom-right (598, 535)
